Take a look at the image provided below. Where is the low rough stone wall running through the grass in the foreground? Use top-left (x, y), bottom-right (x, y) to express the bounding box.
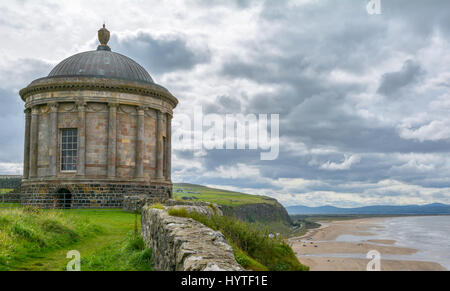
top-left (141, 205), bottom-right (243, 271)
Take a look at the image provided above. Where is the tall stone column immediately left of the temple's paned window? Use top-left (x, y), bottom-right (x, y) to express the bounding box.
top-left (48, 102), bottom-right (59, 177)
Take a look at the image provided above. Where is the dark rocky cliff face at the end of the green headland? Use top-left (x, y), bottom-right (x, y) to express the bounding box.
top-left (222, 199), bottom-right (292, 225)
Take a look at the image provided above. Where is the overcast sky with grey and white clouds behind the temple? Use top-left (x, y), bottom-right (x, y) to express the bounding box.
top-left (0, 0), bottom-right (450, 207)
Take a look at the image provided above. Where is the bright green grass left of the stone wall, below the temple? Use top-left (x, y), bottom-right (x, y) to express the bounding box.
top-left (0, 209), bottom-right (150, 271)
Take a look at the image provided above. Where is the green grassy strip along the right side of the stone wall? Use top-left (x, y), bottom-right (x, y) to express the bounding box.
top-left (169, 208), bottom-right (308, 271)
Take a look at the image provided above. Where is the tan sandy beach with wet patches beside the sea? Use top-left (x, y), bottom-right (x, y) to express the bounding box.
top-left (289, 218), bottom-right (446, 271)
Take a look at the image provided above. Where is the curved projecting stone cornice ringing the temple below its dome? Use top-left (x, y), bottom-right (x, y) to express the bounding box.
top-left (20, 77), bottom-right (178, 108)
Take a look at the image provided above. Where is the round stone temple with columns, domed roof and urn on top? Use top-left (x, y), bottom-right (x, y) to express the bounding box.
top-left (20, 26), bottom-right (178, 208)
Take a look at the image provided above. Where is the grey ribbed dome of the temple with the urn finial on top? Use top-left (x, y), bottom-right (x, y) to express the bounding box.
top-left (48, 25), bottom-right (154, 84)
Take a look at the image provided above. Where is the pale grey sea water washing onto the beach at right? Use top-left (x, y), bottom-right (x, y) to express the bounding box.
top-left (336, 216), bottom-right (450, 270)
